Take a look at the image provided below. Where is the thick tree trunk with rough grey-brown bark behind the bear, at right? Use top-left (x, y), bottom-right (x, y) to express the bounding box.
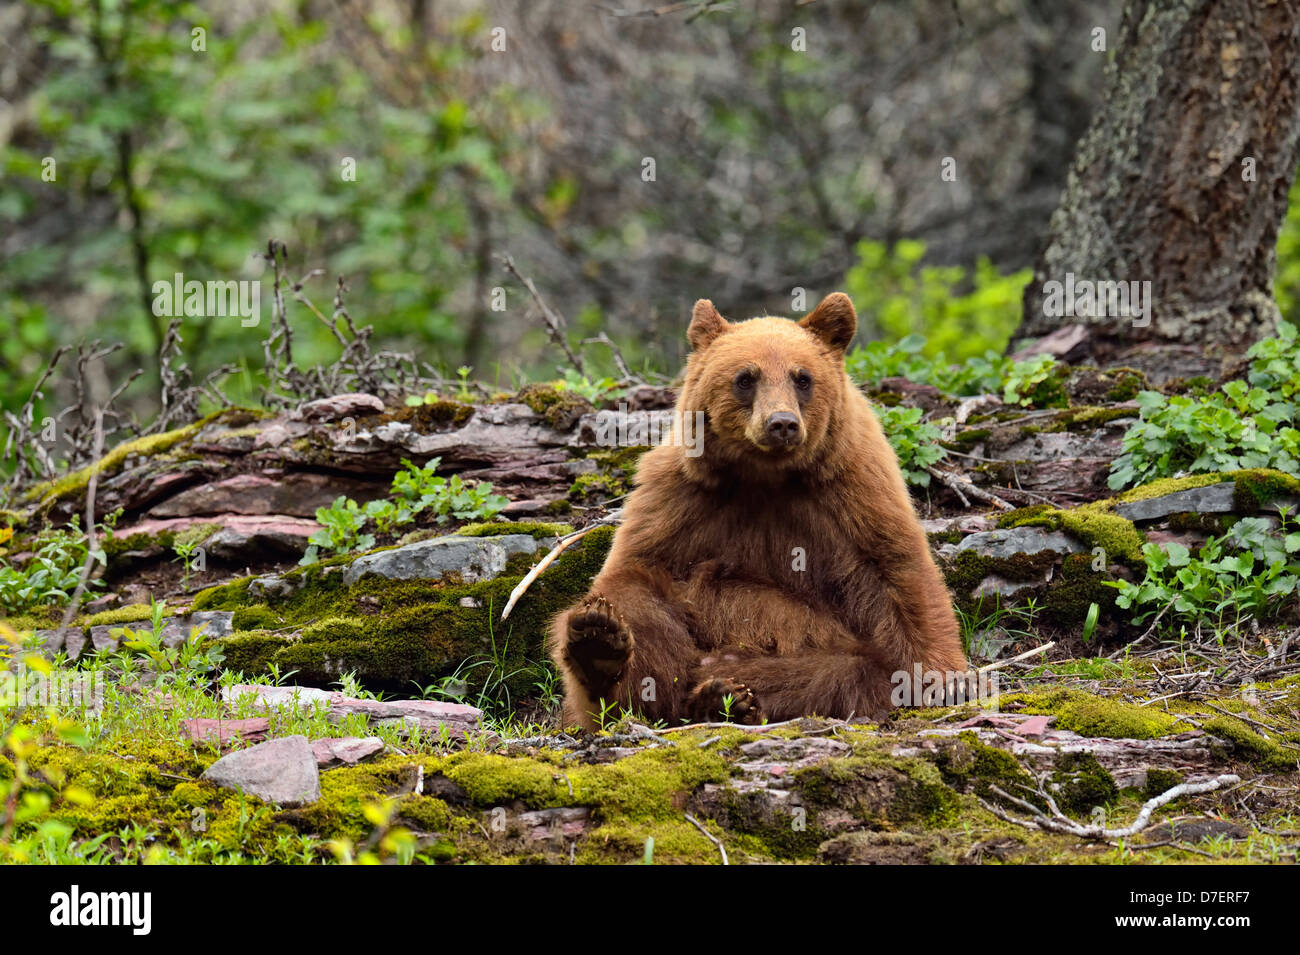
top-left (1013, 0), bottom-right (1300, 379)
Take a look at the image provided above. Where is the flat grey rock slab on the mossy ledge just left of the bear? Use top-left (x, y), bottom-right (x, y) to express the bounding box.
top-left (343, 534), bottom-right (538, 586)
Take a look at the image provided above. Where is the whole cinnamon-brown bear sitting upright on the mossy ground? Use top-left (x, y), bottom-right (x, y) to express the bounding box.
top-left (550, 292), bottom-right (966, 729)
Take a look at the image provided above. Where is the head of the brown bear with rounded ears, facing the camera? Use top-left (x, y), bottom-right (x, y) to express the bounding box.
top-left (679, 292), bottom-right (858, 472)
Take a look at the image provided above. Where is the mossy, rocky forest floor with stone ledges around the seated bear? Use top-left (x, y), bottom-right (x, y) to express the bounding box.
top-left (0, 373), bottom-right (1300, 864)
